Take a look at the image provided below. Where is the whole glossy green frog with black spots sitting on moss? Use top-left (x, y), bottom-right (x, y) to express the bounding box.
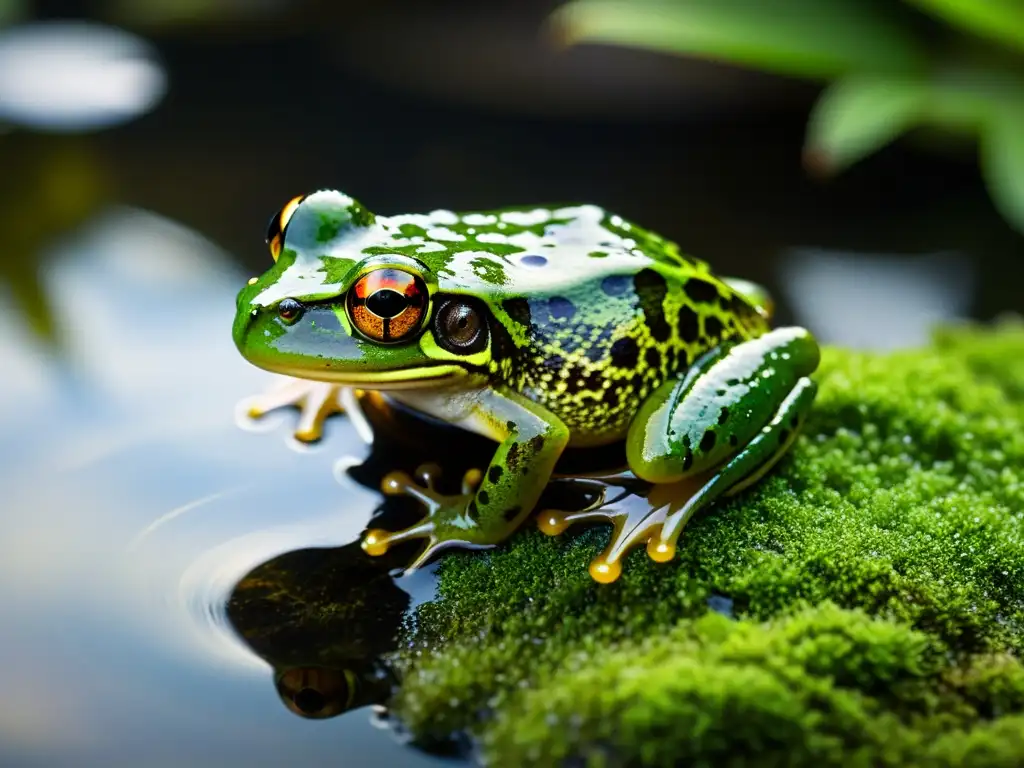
top-left (233, 190), bottom-right (819, 582)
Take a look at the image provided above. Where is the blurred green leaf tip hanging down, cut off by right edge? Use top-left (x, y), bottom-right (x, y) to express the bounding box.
top-left (981, 103), bottom-right (1024, 234)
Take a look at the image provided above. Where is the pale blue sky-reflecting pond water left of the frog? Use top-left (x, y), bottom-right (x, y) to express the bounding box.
top-left (0, 209), bottom-right (446, 766)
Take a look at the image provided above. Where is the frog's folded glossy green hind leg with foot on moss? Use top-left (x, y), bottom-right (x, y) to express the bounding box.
top-left (538, 328), bottom-right (819, 584)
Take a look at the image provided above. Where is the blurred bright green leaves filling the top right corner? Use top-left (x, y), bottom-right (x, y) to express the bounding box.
top-left (552, 0), bottom-right (1024, 232)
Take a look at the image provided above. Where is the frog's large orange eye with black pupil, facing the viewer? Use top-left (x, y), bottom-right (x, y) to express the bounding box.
top-left (348, 268), bottom-right (427, 342)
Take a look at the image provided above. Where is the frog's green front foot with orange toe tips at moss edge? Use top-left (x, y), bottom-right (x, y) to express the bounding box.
top-left (362, 464), bottom-right (493, 573)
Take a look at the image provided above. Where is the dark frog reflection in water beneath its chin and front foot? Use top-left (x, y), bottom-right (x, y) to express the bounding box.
top-left (226, 393), bottom-right (495, 719)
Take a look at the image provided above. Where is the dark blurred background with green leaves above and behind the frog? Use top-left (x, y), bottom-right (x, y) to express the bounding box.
top-left (6, 0), bottom-right (1024, 347)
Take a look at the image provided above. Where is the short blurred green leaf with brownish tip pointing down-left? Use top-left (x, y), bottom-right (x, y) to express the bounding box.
top-left (804, 77), bottom-right (929, 174)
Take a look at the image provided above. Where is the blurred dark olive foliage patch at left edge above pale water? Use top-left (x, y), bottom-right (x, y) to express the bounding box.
top-left (0, 133), bottom-right (110, 343)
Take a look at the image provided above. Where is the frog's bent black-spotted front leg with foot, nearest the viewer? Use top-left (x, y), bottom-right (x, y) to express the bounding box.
top-left (362, 389), bottom-right (569, 570)
